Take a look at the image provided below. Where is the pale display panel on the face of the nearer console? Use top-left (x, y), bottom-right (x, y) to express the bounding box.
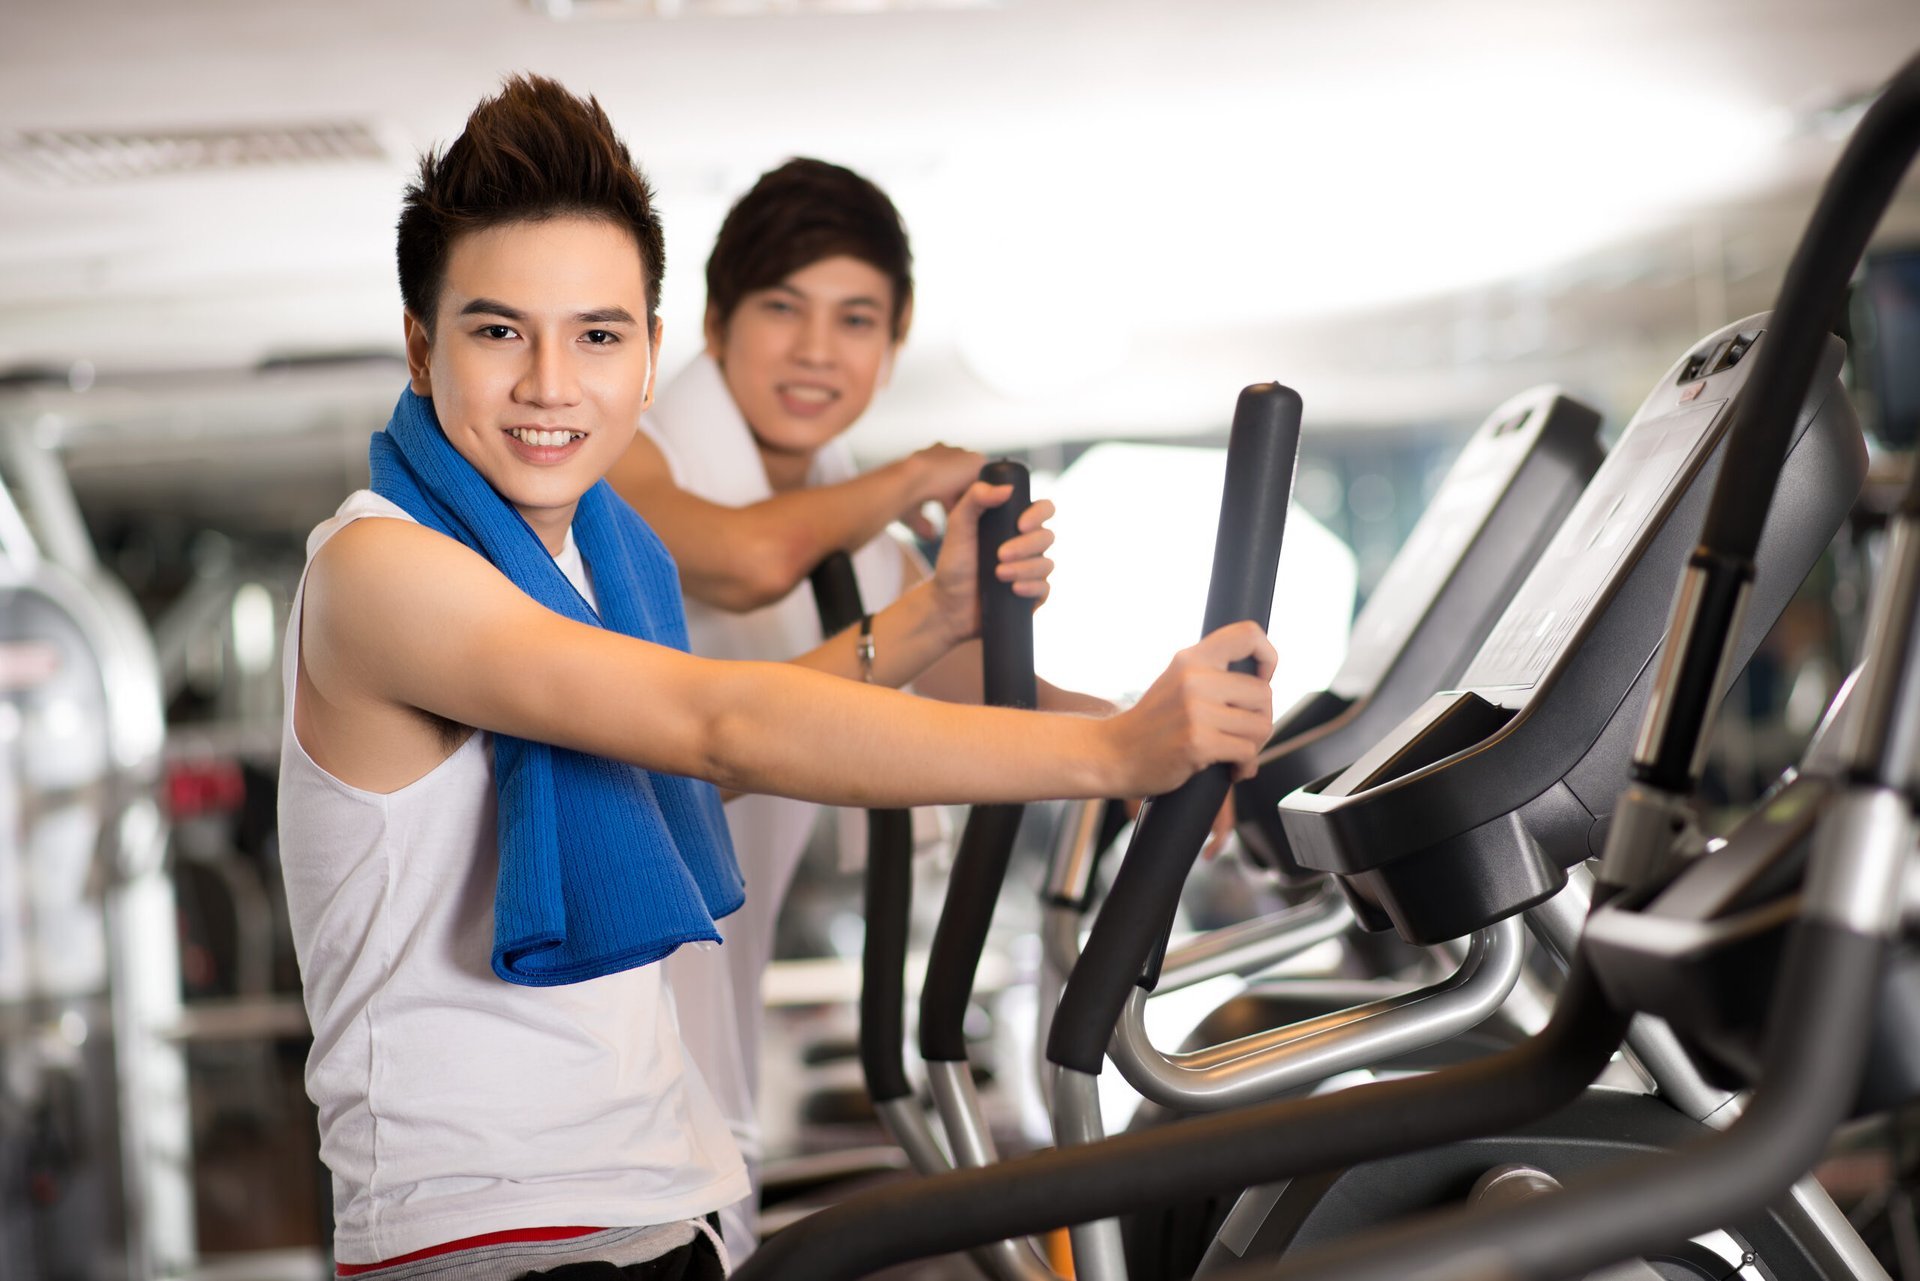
top-left (1461, 401), bottom-right (1726, 689)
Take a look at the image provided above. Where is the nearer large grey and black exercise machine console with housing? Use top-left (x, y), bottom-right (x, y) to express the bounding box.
top-left (1281, 315), bottom-right (1866, 943)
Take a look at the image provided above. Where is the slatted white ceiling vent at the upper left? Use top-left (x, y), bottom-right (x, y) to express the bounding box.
top-left (0, 121), bottom-right (390, 186)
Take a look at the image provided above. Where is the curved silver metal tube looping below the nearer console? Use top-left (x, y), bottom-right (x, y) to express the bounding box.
top-left (1108, 916), bottom-right (1524, 1112)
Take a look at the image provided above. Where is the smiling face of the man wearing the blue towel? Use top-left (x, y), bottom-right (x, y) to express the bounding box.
top-left (407, 217), bottom-right (660, 553)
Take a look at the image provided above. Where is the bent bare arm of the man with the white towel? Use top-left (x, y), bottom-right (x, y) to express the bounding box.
top-left (607, 432), bottom-right (981, 613)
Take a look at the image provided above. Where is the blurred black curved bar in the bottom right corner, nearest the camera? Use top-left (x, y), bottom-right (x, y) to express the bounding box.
top-left (1251, 922), bottom-right (1885, 1281)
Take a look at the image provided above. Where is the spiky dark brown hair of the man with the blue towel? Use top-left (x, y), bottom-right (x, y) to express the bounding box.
top-left (397, 75), bottom-right (666, 334)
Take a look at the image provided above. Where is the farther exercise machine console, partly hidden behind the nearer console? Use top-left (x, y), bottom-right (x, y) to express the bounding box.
top-left (1235, 386), bottom-right (1605, 883)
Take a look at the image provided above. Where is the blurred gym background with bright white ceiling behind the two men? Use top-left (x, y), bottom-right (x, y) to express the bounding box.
top-left (11, 0), bottom-right (1920, 1281)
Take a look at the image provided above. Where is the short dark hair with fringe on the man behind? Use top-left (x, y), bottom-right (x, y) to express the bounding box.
top-left (707, 157), bottom-right (914, 342)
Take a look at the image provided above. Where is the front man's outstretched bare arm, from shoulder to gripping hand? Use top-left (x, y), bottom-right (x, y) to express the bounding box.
top-left (301, 520), bottom-right (1273, 805)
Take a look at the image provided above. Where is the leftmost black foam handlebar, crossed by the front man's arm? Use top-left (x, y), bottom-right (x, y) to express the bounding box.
top-left (810, 551), bottom-right (914, 1102)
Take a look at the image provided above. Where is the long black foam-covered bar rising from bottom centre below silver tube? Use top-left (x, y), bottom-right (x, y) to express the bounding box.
top-left (733, 960), bottom-right (1626, 1281)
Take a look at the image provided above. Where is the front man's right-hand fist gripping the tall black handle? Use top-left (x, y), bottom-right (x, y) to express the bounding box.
top-left (1102, 622), bottom-right (1277, 795)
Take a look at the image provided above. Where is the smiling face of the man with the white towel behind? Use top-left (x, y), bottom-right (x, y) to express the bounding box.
top-left (707, 255), bottom-right (897, 490)
